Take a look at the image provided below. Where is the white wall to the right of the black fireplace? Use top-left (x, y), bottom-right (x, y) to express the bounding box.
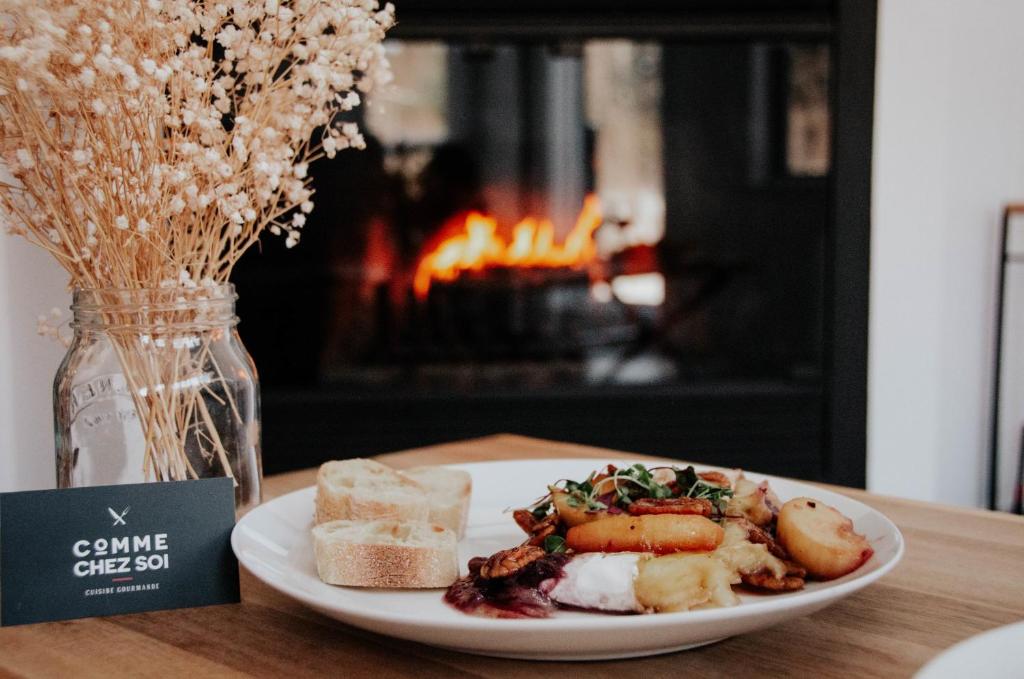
top-left (867, 0), bottom-right (1024, 504)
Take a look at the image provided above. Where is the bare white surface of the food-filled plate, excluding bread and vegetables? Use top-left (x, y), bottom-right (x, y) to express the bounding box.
top-left (231, 459), bottom-right (903, 660)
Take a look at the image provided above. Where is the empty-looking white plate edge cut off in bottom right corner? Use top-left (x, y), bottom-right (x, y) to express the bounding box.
top-left (914, 623), bottom-right (1024, 679)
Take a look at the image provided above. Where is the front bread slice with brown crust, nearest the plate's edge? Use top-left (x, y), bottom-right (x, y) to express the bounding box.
top-left (312, 519), bottom-right (459, 588)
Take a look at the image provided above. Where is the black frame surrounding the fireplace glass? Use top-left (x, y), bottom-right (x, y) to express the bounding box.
top-left (251, 0), bottom-right (877, 487)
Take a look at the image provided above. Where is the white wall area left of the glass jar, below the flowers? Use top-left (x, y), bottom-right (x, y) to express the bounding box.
top-left (0, 236), bottom-right (71, 492)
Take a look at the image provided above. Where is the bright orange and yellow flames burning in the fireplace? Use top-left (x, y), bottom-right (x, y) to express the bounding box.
top-left (413, 195), bottom-right (603, 299)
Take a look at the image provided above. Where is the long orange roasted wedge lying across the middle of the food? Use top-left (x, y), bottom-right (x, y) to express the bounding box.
top-left (565, 514), bottom-right (725, 554)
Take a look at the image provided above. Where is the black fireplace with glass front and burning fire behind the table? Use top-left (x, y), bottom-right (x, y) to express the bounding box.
top-left (237, 0), bottom-right (874, 485)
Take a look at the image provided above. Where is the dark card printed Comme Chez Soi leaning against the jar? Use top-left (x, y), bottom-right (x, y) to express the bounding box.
top-left (0, 478), bottom-right (239, 625)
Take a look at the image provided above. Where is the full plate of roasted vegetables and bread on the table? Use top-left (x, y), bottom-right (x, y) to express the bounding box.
top-left (231, 459), bottom-right (903, 660)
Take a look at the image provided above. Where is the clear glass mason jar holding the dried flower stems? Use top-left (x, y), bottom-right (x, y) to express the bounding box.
top-left (53, 284), bottom-right (261, 512)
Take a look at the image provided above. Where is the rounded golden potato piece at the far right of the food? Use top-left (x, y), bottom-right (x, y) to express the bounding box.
top-left (775, 498), bottom-right (874, 580)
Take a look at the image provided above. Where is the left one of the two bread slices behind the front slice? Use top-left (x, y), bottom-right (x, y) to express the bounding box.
top-left (315, 459), bottom-right (430, 523)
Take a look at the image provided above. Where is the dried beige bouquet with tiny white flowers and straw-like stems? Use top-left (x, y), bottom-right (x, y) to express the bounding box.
top-left (0, 0), bottom-right (393, 489)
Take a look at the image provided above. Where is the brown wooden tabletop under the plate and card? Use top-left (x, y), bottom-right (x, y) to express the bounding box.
top-left (0, 436), bottom-right (1024, 679)
